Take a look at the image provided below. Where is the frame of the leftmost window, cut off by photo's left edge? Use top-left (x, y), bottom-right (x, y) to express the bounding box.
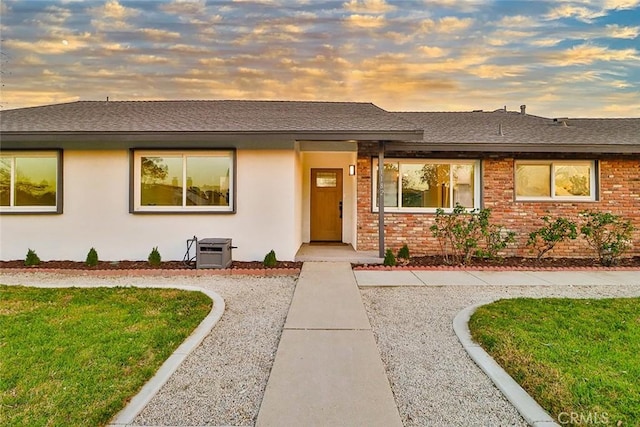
top-left (0, 150), bottom-right (64, 215)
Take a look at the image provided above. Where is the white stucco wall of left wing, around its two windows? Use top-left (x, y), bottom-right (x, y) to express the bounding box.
top-left (0, 150), bottom-right (301, 261)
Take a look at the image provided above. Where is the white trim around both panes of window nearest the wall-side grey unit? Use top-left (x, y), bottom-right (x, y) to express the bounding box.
top-left (132, 149), bottom-right (236, 213)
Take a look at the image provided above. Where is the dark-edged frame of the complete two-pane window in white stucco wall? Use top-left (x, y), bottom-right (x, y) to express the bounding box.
top-left (129, 148), bottom-right (237, 214)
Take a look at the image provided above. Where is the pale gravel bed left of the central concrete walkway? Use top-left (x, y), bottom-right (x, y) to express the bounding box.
top-left (0, 272), bottom-right (296, 426)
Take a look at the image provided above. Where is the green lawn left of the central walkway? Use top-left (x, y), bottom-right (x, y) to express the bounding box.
top-left (0, 285), bottom-right (212, 426)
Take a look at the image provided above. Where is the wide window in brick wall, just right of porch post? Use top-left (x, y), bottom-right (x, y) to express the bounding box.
top-left (372, 159), bottom-right (480, 212)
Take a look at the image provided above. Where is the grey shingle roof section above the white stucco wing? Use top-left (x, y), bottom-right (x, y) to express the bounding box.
top-left (0, 100), bottom-right (417, 132)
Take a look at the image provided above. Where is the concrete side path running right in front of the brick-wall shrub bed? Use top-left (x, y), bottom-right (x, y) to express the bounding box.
top-left (354, 269), bottom-right (640, 287)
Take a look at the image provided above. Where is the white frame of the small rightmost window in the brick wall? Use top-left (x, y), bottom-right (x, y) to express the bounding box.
top-left (513, 159), bottom-right (600, 202)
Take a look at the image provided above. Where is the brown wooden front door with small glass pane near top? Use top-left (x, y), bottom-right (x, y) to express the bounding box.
top-left (311, 169), bottom-right (342, 242)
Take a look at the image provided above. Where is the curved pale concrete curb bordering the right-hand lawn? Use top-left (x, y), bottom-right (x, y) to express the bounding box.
top-left (453, 303), bottom-right (559, 427)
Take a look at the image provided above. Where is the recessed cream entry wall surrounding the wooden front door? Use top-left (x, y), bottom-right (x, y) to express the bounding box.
top-left (302, 152), bottom-right (357, 247)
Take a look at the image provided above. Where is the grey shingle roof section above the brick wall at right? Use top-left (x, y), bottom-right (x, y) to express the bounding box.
top-left (393, 110), bottom-right (640, 151)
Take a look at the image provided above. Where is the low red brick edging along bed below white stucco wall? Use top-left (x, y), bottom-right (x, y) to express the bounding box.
top-left (0, 267), bottom-right (300, 277)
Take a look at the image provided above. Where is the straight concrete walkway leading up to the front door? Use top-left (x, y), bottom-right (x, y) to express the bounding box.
top-left (256, 262), bottom-right (402, 427)
